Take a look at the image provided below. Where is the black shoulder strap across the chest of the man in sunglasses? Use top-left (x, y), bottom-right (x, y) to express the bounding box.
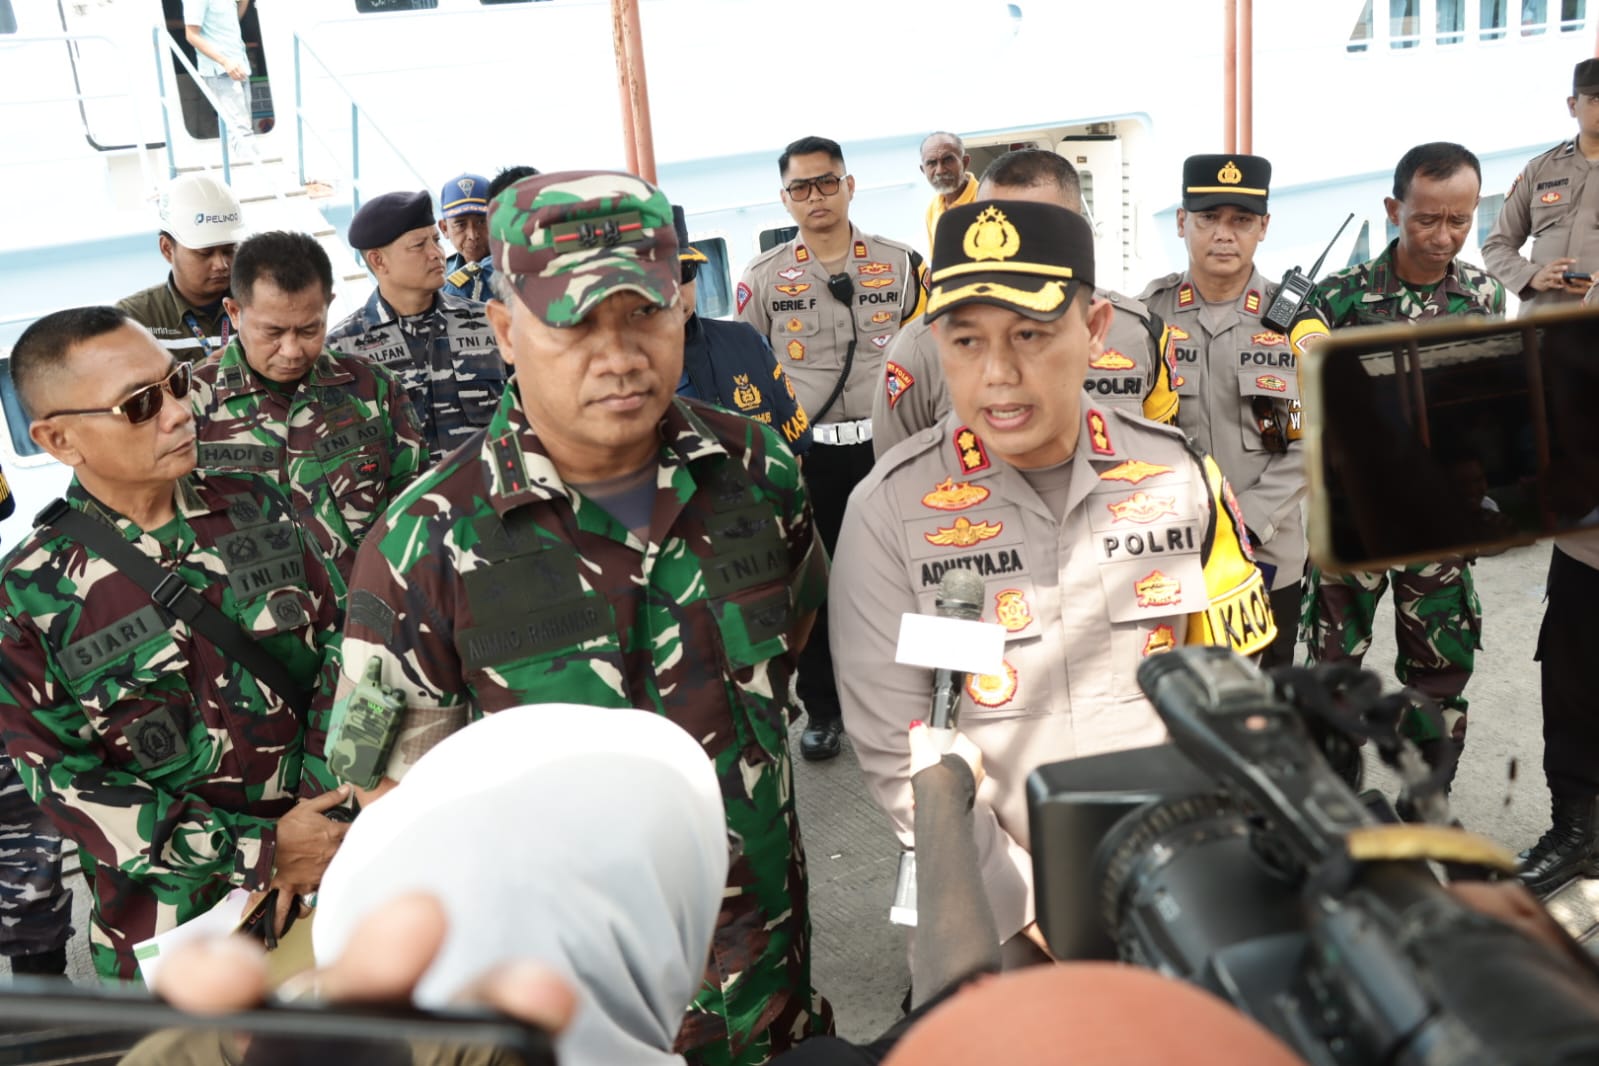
top-left (38, 499), bottom-right (310, 716)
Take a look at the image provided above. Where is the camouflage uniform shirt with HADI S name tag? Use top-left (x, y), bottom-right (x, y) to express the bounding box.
top-left (190, 340), bottom-right (427, 579)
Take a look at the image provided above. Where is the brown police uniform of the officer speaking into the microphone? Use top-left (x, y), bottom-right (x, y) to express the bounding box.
top-left (828, 408), bottom-right (1274, 938)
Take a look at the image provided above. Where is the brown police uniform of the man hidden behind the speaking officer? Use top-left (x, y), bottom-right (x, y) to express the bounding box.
top-left (871, 289), bottom-right (1177, 459)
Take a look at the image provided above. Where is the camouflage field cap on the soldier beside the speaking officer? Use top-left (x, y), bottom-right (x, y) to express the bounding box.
top-left (489, 171), bottom-right (678, 328)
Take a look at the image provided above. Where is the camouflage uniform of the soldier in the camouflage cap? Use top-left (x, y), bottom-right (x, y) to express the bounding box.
top-left (336, 380), bottom-right (831, 1063)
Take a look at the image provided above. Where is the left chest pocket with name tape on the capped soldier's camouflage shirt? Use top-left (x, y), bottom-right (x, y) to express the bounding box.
top-left (456, 536), bottom-right (625, 706)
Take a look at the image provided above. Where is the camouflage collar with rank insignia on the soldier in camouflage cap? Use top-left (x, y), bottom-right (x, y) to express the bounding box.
top-left (481, 377), bottom-right (728, 516)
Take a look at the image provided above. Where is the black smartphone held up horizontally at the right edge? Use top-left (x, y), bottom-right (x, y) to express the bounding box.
top-left (1298, 307), bottom-right (1599, 571)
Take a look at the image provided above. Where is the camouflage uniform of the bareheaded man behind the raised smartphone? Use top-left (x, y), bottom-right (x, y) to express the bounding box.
top-left (1300, 241), bottom-right (1505, 742)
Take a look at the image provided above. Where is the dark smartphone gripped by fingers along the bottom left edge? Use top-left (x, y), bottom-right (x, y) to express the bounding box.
top-left (0, 978), bottom-right (555, 1066)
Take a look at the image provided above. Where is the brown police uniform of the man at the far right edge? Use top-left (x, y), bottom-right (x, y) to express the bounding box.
top-left (1482, 141), bottom-right (1599, 312)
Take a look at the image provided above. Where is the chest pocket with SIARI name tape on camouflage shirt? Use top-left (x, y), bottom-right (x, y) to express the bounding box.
top-left (59, 604), bottom-right (211, 782)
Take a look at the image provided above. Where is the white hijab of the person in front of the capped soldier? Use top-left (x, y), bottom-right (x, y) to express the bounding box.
top-left (313, 703), bottom-right (728, 1066)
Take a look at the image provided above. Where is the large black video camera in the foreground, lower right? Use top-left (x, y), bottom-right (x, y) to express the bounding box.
top-left (1028, 647), bottom-right (1599, 1066)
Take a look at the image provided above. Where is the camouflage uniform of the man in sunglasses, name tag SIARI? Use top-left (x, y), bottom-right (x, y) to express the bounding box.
top-left (0, 473), bottom-right (344, 980)
